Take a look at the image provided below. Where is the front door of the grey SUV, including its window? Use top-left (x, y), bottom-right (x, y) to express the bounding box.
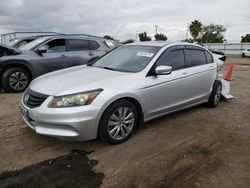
top-left (33, 39), bottom-right (68, 75)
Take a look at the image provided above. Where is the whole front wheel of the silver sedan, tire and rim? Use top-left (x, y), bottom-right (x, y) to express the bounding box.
top-left (98, 100), bottom-right (138, 144)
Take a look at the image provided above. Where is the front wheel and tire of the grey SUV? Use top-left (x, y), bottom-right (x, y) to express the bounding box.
top-left (2, 67), bottom-right (31, 92)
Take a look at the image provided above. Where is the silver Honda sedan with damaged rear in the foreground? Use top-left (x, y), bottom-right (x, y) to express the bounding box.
top-left (21, 42), bottom-right (221, 144)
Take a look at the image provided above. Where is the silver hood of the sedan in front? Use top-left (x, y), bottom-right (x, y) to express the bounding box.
top-left (30, 65), bottom-right (134, 96)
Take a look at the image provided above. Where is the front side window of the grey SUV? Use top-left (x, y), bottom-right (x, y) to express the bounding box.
top-left (40, 39), bottom-right (66, 53)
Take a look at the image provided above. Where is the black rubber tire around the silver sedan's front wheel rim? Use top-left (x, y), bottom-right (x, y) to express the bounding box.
top-left (98, 100), bottom-right (138, 144)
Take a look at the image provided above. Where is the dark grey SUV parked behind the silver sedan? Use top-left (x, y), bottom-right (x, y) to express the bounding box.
top-left (0, 36), bottom-right (110, 92)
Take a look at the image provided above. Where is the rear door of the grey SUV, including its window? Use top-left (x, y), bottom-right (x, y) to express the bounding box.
top-left (67, 39), bottom-right (100, 67)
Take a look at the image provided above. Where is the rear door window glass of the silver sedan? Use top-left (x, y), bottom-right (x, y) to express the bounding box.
top-left (187, 49), bottom-right (207, 67)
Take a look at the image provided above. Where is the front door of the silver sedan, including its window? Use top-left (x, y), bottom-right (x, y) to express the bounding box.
top-left (144, 46), bottom-right (189, 118)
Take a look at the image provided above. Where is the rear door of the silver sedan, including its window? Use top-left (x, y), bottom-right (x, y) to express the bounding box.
top-left (185, 46), bottom-right (217, 103)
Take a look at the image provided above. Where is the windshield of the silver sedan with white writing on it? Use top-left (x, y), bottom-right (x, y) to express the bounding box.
top-left (90, 45), bottom-right (160, 72)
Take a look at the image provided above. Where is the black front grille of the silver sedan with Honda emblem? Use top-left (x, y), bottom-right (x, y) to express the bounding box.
top-left (23, 89), bottom-right (49, 108)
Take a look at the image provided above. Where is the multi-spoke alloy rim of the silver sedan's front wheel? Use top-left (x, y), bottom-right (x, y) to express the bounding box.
top-left (108, 107), bottom-right (135, 140)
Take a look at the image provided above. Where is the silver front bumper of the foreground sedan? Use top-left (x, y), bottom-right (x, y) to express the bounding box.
top-left (21, 97), bottom-right (100, 141)
